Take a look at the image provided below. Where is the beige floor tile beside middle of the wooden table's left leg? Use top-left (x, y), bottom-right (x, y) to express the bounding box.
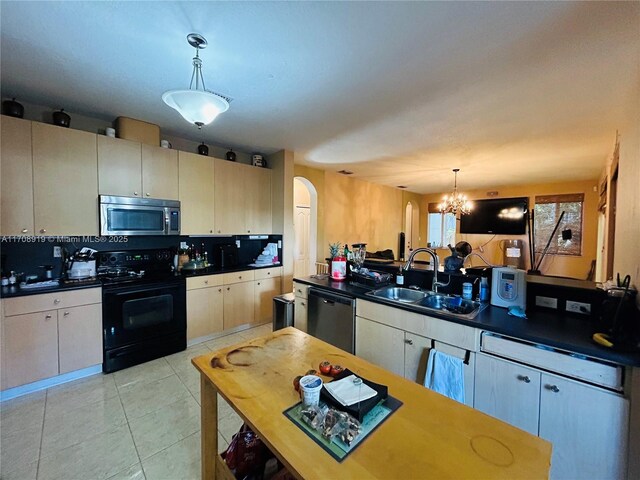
top-left (129, 396), bottom-right (200, 460)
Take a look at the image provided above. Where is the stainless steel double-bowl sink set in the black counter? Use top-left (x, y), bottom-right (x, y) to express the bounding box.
top-left (367, 287), bottom-right (487, 319)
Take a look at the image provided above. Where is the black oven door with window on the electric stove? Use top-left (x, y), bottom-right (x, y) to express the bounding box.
top-left (102, 283), bottom-right (187, 352)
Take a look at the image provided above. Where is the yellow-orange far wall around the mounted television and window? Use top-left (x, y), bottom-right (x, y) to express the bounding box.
top-left (421, 179), bottom-right (598, 279)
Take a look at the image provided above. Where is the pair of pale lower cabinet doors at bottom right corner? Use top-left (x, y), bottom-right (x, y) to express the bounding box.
top-left (475, 353), bottom-right (629, 480)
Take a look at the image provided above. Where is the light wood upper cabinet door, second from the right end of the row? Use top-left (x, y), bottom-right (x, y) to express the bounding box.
top-left (213, 159), bottom-right (246, 234)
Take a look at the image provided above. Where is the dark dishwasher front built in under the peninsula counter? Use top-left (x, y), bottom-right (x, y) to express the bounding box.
top-left (307, 287), bottom-right (356, 353)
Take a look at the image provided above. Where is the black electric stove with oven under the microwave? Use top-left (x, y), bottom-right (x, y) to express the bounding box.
top-left (97, 249), bottom-right (187, 373)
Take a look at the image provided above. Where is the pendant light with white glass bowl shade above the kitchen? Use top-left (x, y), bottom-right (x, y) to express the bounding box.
top-left (162, 33), bottom-right (230, 128)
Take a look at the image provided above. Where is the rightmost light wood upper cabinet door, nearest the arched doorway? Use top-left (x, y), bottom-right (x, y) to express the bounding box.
top-left (243, 167), bottom-right (272, 233)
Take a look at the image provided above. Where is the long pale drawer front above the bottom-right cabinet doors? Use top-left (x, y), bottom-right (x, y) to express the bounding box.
top-left (481, 332), bottom-right (624, 390)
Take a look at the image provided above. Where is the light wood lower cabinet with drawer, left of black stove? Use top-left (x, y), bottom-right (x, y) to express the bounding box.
top-left (1, 288), bottom-right (102, 390)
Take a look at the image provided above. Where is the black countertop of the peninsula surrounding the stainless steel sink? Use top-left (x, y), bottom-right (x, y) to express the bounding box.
top-left (294, 277), bottom-right (640, 367)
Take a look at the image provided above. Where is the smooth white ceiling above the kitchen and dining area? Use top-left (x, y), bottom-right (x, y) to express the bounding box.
top-left (0, 0), bottom-right (640, 193)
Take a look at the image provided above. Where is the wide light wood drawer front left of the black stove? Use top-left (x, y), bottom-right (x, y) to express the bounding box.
top-left (4, 288), bottom-right (102, 317)
